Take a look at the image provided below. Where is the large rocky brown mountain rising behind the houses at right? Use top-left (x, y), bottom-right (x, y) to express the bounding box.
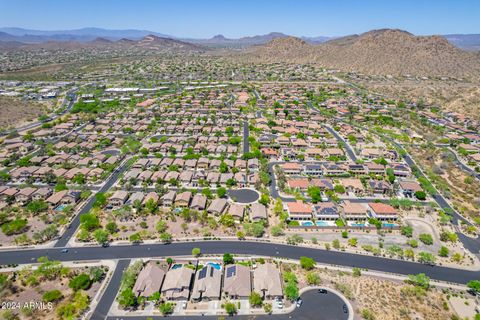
top-left (247, 29), bottom-right (480, 78)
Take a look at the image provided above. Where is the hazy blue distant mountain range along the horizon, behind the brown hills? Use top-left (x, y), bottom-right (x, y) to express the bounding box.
top-left (0, 27), bottom-right (480, 50)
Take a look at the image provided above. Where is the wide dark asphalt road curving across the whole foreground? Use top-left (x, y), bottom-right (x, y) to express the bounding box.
top-left (0, 240), bottom-right (480, 284)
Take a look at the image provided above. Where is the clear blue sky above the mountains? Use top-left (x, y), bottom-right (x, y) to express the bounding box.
top-left (0, 0), bottom-right (480, 38)
